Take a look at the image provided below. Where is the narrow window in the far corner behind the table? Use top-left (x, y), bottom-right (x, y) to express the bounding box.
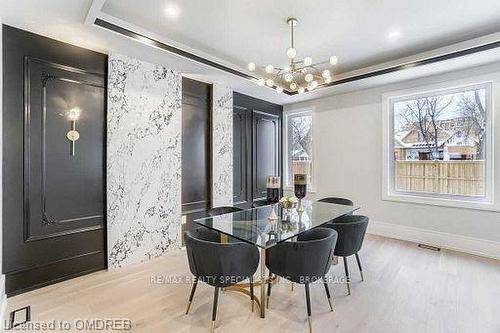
top-left (285, 110), bottom-right (313, 189)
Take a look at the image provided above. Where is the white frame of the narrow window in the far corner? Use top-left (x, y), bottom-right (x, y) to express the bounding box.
top-left (283, 107), bottom-right (317, 193)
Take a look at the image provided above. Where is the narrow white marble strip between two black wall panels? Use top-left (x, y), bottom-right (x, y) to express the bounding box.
top-left (212, 84), bottom-right (233, 207)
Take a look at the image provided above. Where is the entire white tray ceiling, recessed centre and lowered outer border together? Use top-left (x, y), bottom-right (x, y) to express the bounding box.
top-left (0, 0), bottom-right (500, 104)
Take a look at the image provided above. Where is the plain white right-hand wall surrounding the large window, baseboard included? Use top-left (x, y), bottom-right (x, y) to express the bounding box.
top-left (285, 63), bottom-right (500, 258)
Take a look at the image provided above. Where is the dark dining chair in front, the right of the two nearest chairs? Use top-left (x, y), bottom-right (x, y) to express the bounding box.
top-left (262, 228), bottom-right (337, 332)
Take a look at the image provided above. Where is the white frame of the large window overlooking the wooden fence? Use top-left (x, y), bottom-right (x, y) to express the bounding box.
top-left (382, 80), bottom-right (500, 211)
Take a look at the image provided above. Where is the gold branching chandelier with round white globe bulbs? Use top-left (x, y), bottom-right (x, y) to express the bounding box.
top-left (248, 17), bottom-right (338, 94)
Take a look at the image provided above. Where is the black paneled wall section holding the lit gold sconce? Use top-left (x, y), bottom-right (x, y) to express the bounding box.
top-left (3, 26), bottom-right (107, 295)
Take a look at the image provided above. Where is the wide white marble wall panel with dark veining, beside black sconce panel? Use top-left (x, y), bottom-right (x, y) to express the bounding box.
top-left (107, 54), bottom-right (182, 268)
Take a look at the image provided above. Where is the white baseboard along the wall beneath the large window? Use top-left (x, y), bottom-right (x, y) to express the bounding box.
top-left (367, 221), bottom-right (500, 260)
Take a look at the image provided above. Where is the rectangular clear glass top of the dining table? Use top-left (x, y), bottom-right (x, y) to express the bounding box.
top-left (194, 200), bottom-right (359, 249)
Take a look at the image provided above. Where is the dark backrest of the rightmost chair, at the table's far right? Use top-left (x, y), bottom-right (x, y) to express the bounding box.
top-left (328, 215), bottom-right (369, 257)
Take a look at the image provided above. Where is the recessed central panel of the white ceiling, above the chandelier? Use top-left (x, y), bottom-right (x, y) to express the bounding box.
top-left (102, 0), bottom-right (500, 73)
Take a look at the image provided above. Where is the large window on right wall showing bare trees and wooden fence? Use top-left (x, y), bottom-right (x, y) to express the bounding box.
top-left (384, 84), bottom-right (493, 208)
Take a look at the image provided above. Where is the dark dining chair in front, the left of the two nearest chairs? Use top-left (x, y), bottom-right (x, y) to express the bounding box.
top-left (184, 228), bottom-right (259, 331)
